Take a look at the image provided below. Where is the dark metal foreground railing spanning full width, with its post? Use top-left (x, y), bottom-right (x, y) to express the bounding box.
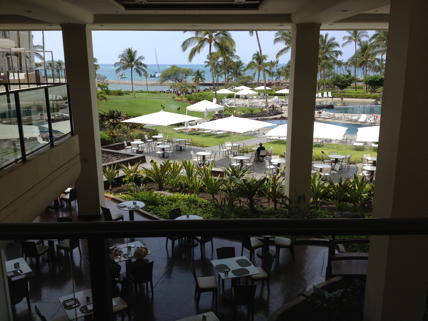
top-left (0, 218), bottom-right (428, 320)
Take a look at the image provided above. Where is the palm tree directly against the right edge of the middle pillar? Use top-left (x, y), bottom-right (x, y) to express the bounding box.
top-left (318, 33), bottom-right (342, 86)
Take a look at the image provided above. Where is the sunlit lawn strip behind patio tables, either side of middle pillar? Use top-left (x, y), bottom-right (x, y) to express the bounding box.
top-left (264, 141), bottom-right (377, 163)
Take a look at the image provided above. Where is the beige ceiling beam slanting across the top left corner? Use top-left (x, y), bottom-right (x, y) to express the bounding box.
top-left (0, 0), bottom-right (93, 24)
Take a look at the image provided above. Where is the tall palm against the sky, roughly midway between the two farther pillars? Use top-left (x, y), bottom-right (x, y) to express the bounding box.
top-left (181, 31), bottom-right (235, 97)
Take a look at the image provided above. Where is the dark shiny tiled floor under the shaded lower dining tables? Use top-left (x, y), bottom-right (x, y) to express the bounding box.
top-left (6, 201), bottom-right (327, 321)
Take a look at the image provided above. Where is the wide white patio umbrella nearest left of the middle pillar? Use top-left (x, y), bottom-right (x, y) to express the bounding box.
top-left (193, 116), bottom-right (272, 134)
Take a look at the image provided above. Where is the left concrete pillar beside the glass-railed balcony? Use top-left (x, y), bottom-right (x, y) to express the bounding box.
top-left (62, 24), bottom-right (104, 216)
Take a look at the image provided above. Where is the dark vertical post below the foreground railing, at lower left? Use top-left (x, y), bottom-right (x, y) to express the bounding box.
top-left (88, 237), bottom-right (113, 321)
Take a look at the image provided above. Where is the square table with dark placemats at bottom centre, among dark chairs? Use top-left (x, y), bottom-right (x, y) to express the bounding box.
top-left (211, 256), bottom-right (260, 280)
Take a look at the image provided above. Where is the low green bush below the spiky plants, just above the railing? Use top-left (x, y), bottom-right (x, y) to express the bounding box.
top-left (121, 191), bottom-right (216, 219)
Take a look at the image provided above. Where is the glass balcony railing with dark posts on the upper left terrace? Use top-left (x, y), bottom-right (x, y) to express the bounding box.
top-left (0, 84), bottom-right (72, 169)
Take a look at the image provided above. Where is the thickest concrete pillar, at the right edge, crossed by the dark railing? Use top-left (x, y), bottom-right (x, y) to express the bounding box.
top-left (364, 0), bottom-right (428, 321)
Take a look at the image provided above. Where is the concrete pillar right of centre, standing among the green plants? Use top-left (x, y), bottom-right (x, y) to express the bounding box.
top-left (285, 23), bottom-right (320, 202)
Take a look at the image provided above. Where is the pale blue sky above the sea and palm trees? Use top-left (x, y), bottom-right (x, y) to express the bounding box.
top-left (33, 31), bottom-right (371, 64)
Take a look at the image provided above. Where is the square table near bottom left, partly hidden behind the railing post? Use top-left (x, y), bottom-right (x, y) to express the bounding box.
top-left (59, 289), bottom-right (128, 320)
